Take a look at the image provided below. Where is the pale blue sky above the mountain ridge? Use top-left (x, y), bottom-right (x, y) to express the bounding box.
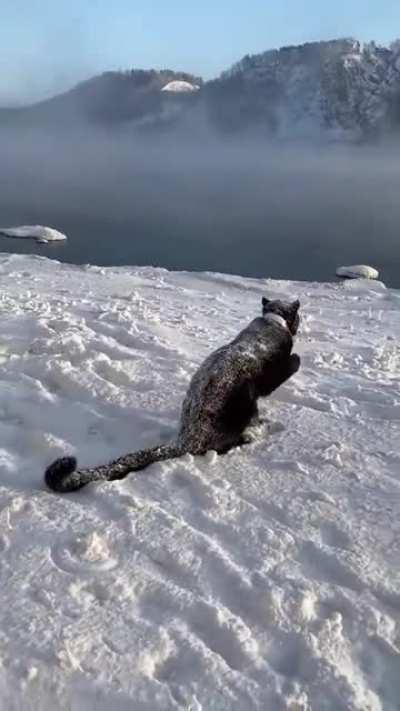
top-left (0, 0), bottom-right (400, 105)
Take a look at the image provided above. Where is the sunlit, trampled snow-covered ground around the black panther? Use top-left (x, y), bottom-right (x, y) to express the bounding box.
top-left (0, 254), bottom-right (400, 711)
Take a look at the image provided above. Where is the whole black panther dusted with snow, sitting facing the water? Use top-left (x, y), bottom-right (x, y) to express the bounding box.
top-left (45, 298), bottom-right (300, 492)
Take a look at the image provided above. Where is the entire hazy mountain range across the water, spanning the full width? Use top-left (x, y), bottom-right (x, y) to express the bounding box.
top-left (0, 39), bottom-right (400, 140)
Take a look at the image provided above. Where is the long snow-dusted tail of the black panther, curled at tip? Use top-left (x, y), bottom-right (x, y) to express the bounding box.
top-left (44, 444), bottom-right (185, 494)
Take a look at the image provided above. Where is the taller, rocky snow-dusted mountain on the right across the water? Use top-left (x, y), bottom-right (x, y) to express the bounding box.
top-left (209, 39), bottom-right (400, 139)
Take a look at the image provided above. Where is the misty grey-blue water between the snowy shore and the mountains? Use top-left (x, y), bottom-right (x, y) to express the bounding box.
top-left (0, 128), bottom-right (400, 287)
